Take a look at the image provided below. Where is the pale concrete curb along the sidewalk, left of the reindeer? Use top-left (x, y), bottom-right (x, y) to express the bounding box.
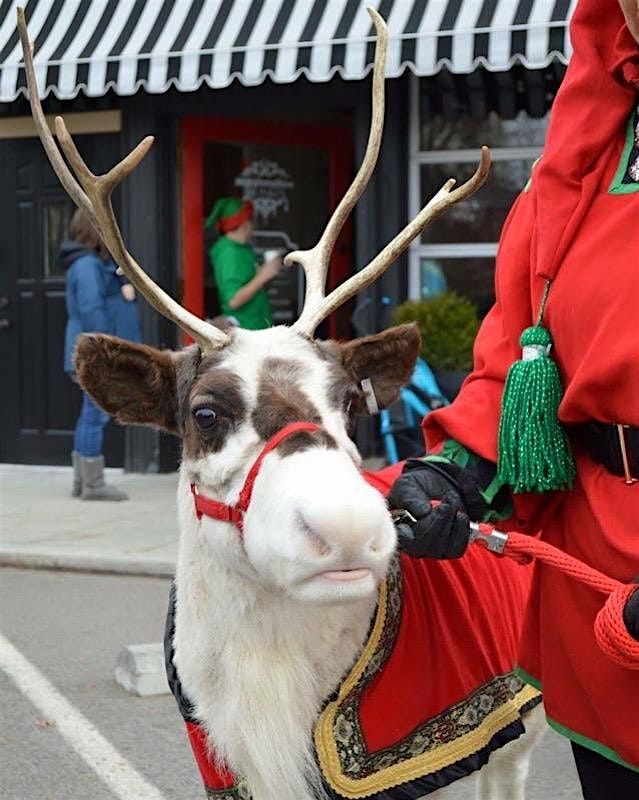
top-left (0, 550), bottom-right (175, 578)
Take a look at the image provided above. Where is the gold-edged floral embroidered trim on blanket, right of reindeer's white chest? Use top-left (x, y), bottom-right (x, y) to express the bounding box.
top-left (315, 560), bottom-right (540, 798)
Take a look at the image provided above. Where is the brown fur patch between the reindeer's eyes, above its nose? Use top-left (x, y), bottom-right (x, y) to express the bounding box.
top-left (252, 358), bottom-right (337, 455)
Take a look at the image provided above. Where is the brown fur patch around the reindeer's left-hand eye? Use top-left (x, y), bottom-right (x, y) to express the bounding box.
top-left (184, 368), bottom-right (247, 458)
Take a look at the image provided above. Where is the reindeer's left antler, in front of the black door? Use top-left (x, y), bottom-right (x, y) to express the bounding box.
top-left (18, 8), bottom-right (229, 351)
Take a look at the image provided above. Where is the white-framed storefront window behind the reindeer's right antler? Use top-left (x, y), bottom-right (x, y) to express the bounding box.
top-left (409, 74), bottom-right (548, 316)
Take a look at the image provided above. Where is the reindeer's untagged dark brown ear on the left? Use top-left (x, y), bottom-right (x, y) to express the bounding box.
top-left (74, 333), bottom-right (200, 434)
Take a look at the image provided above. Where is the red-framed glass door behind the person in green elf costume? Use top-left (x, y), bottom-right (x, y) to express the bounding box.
top-left (181, 117), bottom-right (353, 338)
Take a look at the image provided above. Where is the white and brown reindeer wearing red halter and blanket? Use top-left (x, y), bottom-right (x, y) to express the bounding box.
top-left (19, 11), bottom-right (539, 800)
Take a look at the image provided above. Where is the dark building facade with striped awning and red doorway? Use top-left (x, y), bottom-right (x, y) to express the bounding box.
top-left (0, 0), bottom-right (572, 471)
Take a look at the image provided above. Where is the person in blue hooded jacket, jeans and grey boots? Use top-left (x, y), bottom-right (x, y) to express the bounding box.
top-left (58, 209), bottom-right (142, 500)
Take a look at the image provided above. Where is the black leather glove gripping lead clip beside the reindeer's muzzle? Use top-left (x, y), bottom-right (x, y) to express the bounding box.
top-left (388, 459), bottom-right (487, 558)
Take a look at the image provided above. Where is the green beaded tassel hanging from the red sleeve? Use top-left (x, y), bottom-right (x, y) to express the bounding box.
top-left (497, 324), bottom-right (576, 493)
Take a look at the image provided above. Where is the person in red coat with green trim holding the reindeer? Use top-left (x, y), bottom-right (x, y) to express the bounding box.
top-left (389, 0), bottom-right (639, 800)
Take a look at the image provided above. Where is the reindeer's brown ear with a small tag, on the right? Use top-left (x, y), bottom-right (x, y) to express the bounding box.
top-left (340, 323), bottom-right (421, 410)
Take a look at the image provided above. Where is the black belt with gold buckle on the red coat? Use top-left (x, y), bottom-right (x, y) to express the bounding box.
top-left (569, 422), bottom-right (639, 483)
